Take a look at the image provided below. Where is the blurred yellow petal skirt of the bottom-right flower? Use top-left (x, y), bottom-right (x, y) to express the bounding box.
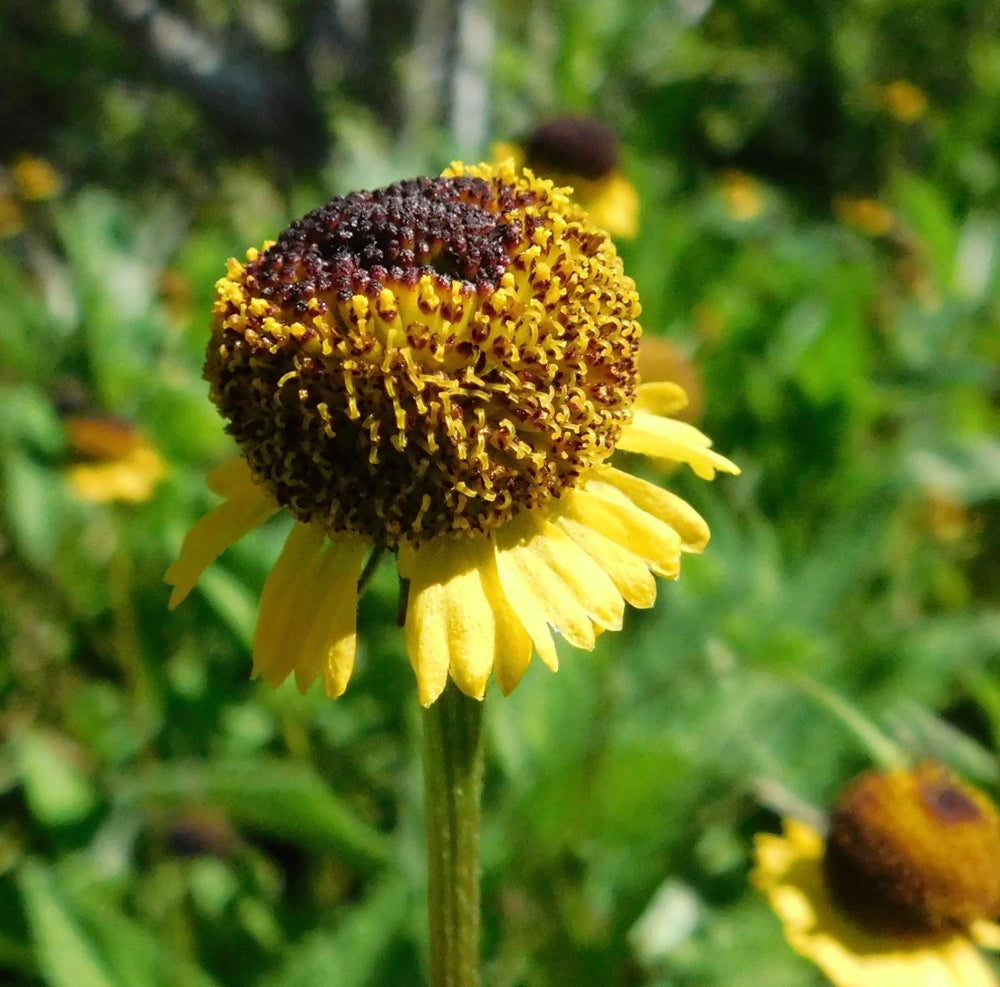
top-left (752, 819), bottom-right (997, 987)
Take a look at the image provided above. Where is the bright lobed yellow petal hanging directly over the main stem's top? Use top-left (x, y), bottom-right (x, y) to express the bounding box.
top-left (399, 536), bottom-right (497, 706)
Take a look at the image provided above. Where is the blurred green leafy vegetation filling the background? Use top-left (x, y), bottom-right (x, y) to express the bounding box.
top-left (0, 0), bottom-right (1000, 987)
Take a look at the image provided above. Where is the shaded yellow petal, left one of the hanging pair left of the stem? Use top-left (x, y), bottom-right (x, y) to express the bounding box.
top-left (253, 521), bottom-right (326, 688)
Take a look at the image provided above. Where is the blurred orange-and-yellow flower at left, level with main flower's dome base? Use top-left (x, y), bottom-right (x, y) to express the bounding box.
top-left (65, 416), bottom-right (167, 504)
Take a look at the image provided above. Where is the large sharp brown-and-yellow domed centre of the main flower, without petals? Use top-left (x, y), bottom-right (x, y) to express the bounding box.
top-left (206, 166), bottom-right (640, 547)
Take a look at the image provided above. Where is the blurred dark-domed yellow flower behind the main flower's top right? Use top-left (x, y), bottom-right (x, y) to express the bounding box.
top-left (493, 117), bottom-right (639, 237)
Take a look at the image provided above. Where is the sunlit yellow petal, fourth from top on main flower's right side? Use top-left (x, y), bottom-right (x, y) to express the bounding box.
top-left (560, 483), bottom-right (681, 579)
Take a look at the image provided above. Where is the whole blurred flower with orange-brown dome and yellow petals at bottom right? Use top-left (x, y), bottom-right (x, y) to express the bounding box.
top-left (752, 763), bottom-right (1000, 987)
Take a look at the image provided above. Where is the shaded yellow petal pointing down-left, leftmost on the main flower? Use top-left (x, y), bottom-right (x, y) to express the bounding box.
top-left (164, 459), bottom-right (278, 609)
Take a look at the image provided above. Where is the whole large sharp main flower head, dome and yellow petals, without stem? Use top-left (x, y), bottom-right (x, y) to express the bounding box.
top-left (167, 164), bottom-right (735, 705)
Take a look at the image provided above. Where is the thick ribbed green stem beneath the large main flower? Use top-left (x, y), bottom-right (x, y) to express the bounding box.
top-left (424, 683), bottom-right (483, 987)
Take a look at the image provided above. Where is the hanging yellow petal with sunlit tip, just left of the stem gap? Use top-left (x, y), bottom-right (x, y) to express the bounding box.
top-left (295, 534), bottom-right (368, 699)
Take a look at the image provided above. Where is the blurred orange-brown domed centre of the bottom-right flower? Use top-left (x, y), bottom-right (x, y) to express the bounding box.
top-left (824, 762), bottom-right (1000, 934)
